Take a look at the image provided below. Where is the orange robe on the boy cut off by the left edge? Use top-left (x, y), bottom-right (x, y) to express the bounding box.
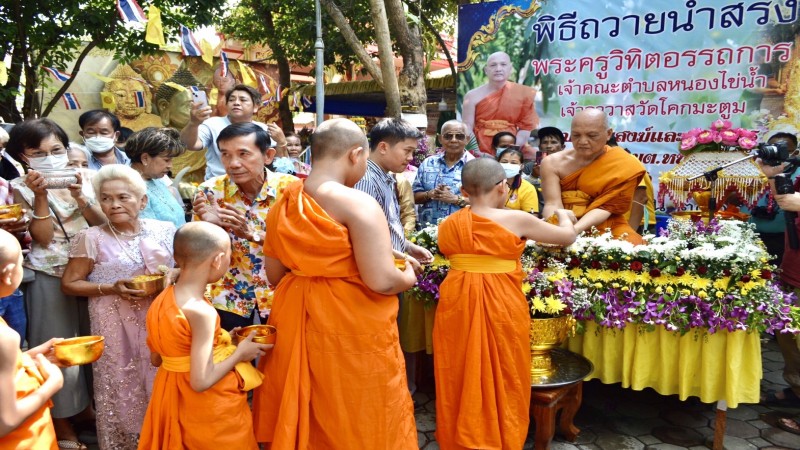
top-left (0, 318), bottom-right (58, 450)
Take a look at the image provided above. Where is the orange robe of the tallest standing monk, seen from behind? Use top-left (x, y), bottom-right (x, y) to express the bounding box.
top-left (253, 181), bottom-right (418, 450)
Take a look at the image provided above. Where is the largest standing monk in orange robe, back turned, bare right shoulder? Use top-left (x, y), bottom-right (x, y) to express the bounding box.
top-left (253, 119), bottom-right (418, 450)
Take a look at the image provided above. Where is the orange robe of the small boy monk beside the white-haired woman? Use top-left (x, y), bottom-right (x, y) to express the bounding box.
top-left (139, 286), bottom-right (258, 450)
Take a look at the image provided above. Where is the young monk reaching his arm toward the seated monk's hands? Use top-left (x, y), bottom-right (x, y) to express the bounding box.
top-left (433, 158), bottom-right (576, 450)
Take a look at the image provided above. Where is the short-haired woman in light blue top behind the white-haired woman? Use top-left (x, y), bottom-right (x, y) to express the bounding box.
top-left (125, 127), bottom-right (186, 227)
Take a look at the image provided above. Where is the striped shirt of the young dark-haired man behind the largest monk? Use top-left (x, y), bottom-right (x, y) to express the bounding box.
top-left (353, 159), bottom-right (406, 252)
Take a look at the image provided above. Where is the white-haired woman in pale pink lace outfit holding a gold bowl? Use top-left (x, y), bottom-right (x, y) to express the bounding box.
top-left (62, 164), bottom-right (175, 449)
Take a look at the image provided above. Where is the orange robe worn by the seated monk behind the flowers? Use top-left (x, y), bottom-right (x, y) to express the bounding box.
top-left (561, 146), bottom-right (645, 244)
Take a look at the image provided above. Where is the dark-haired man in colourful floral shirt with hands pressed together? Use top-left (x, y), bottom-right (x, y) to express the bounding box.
top-left (193, 123), bottom-right (297, 330)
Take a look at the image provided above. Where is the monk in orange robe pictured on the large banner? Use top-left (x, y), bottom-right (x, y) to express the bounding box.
top-left (461, 52), bottom-right (539, 156)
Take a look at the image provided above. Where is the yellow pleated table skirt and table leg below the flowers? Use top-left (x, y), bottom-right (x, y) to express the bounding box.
top-left (567, 322), bottom-right (762, 449)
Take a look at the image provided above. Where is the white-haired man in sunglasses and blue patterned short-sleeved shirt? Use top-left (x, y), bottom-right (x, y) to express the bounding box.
top-left (412, 120), bottom-right (473, 224)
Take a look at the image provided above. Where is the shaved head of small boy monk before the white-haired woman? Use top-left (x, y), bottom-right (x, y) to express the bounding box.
top-left (172, 222), bottom-right (231, 267)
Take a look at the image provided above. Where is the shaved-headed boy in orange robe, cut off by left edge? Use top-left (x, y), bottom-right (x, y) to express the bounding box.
top-left (0, 230), bottom-right (64, 450)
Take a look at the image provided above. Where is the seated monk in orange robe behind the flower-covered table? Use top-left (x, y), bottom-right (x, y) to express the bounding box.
top-left (540, 109), bottom-right (645, 244)
